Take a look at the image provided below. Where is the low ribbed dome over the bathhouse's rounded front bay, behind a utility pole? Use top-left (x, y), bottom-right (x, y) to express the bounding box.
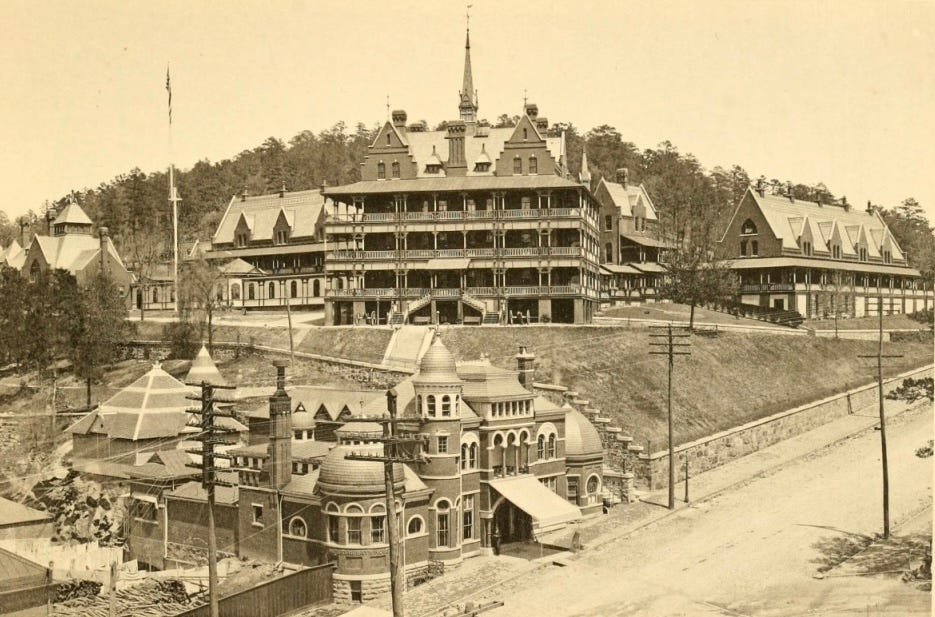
top-left (318, 444), bottom-right (405, 495)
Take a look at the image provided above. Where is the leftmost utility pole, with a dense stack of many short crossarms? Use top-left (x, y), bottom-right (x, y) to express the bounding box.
top-left (186, 381), bottom-right (235, 617)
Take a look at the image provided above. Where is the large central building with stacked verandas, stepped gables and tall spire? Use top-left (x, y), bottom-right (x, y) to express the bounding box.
top-left (324, 28), bottom-right (600, 325)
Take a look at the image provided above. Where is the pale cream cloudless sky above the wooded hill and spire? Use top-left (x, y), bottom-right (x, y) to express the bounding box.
top-left (0, 0), bottom-right (935, 221)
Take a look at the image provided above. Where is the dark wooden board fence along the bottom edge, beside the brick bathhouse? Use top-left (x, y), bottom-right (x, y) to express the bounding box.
top-left (175, 563), bottom-right (335, 617)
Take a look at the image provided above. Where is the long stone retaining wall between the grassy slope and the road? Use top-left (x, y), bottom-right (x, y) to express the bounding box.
top-left (632, 365), bottom-right (933, 490)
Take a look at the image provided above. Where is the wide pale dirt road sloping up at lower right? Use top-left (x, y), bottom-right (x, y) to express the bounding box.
top-left (483, 408), bottom-right (933, 617)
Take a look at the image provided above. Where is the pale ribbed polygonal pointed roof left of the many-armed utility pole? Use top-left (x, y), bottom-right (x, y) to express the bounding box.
top-left (97, 363), bottom-right (192, 441)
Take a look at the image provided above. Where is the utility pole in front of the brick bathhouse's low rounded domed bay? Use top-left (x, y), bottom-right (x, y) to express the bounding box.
top-left (344, 390), bottom-right (423, 617)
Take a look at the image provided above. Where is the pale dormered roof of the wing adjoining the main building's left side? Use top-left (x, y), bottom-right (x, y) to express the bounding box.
top-left (213, 189), bottom-right (325, 248)
